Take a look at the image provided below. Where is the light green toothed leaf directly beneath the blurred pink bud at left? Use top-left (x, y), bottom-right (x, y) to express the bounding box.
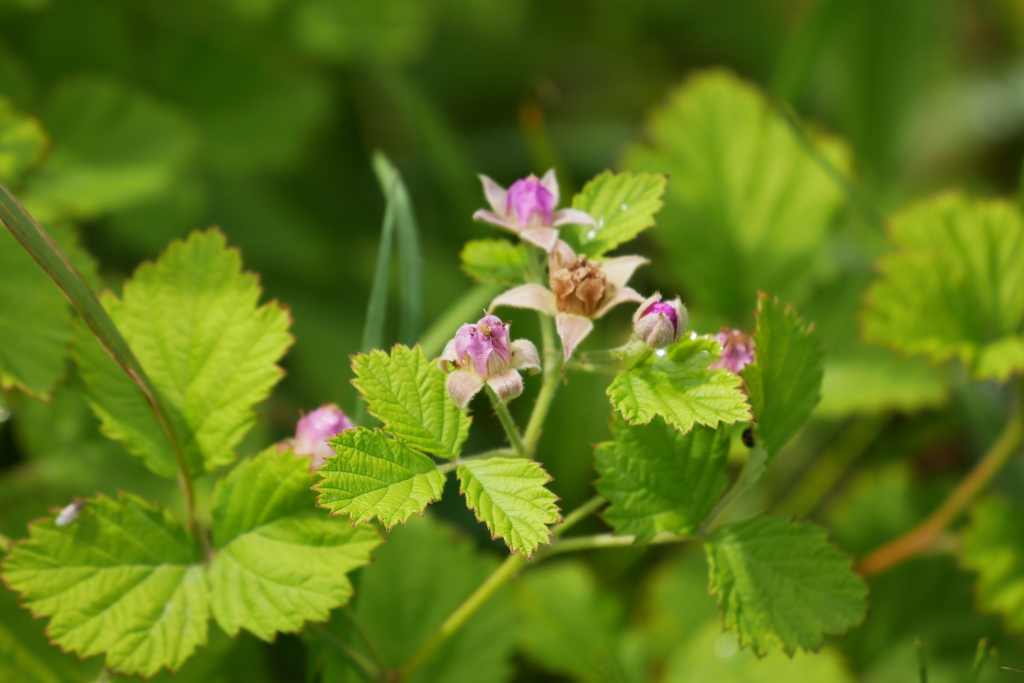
top-left (209, 446), bottom-right (381, 640)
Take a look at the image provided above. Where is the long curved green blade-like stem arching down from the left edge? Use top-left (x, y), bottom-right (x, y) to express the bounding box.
top-left (0, 182), bottom-right (209, 555)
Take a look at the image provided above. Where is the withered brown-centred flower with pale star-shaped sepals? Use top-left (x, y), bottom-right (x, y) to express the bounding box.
top-left (490, 241), bottom-right (648, 359)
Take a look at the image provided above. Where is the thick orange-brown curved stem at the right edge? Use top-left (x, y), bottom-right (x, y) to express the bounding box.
top-left (855, 411), bottom-right (1024, 577)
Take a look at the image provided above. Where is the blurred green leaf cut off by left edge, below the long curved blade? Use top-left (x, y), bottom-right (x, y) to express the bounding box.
top-left (0, 225), bottom-right (72, 396)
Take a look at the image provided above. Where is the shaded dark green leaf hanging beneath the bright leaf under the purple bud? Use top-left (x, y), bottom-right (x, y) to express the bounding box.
top-left (596, 413), bottom-right (730, 543)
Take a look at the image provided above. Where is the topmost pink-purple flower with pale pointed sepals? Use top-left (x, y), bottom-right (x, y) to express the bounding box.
top-left (473, 169), bottom-right (596, 252)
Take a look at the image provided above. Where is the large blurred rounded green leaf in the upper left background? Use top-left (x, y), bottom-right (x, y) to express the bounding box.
top-left (25, 79), bottom-right (196, 222)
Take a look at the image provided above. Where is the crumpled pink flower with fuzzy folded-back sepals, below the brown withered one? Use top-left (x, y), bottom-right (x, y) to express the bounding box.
top-left (437, 315), bottom-right (541, 410)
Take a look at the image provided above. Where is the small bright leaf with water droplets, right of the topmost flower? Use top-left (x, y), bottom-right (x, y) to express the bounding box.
top-left (564, 171), bottom-right (668, 257)
